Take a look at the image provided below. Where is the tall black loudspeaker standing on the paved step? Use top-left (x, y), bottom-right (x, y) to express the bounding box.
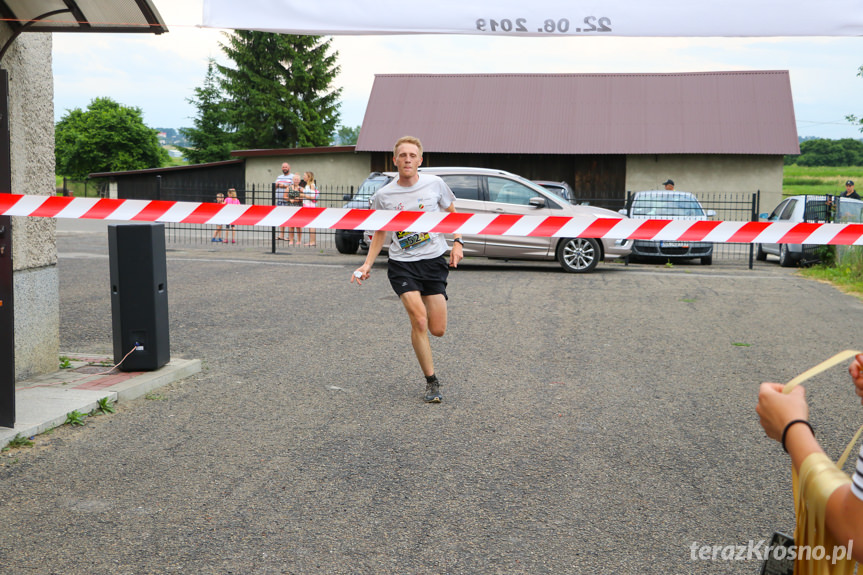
top-left (108, 224), bottom-right (171, 371)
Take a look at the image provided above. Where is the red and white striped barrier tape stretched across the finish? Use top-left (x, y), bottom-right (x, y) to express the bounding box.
top-left (0, 194), bottom-right (863, 246)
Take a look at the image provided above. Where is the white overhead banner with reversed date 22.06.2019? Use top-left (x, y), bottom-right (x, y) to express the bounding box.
top-left (203, 0), bottom-right (863, 37)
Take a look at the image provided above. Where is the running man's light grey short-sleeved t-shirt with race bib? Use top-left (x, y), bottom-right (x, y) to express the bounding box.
top-left (372, 173), bottom-right (455, 262)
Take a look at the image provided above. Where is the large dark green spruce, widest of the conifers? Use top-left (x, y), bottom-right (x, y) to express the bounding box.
top-left (218, 30), bottom-right (341, 149)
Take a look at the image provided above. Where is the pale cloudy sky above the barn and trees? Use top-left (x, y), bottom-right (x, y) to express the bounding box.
top-left (53, 0), bottom-right (863, 138)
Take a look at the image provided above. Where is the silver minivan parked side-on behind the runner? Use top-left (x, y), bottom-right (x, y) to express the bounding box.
top-left (367, 168), bottom-right (632, 273)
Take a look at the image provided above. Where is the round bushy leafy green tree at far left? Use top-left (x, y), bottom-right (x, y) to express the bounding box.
top-left (54, 98), bottom-right (169, 179)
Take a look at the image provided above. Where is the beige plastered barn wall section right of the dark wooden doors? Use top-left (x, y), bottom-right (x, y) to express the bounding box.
top-left (626, 154), bottom-right (784, 219)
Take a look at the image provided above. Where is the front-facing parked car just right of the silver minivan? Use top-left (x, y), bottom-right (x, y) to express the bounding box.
top-left (620, 190), bottom-right (716, 265)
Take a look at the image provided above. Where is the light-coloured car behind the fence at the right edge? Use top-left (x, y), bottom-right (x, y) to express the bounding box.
top-left (755, 195), bottom-right (863, 267)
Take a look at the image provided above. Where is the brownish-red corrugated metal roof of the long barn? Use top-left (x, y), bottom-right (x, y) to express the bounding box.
top-left (356, 70), bottom-right (800, 155)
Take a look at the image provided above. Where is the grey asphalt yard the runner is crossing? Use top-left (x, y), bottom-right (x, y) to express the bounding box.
top-left (0, 219), bottom-right (863, 575)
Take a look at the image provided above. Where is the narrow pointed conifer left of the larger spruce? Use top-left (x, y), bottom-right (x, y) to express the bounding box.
top-left (180, 58), bottom-right (233, 164)
